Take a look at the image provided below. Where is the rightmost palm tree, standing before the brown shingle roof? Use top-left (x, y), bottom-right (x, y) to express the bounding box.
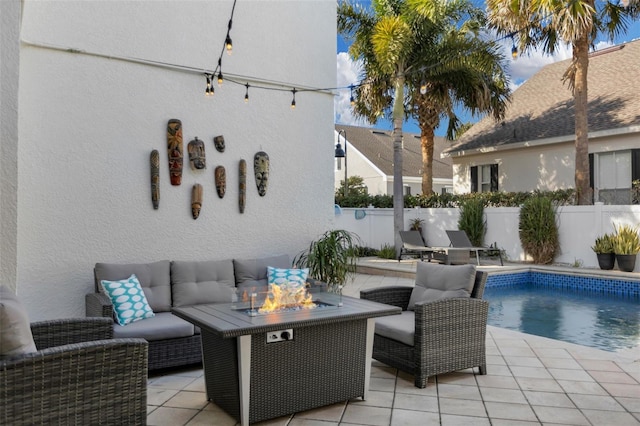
top-left (487, 0), bottom-right (640, 205)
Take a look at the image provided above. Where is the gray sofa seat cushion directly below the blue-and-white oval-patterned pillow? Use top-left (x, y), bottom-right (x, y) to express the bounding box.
top-left (113, 312), bottom-right (195, 342)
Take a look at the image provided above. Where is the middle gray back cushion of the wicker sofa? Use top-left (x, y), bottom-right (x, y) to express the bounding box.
top-left (171, 259), bottom-right (235, 307)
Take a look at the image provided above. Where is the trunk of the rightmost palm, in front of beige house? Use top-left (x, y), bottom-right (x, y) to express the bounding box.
top-left (573, 31), bottom-right (593, 205)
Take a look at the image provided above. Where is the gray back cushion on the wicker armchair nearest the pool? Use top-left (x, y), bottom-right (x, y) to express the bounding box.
top-left (407, 262), bottom-right (476, 310)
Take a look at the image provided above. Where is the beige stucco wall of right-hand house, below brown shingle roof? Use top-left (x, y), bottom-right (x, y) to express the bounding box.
top-left (453, 133), bottom-right (640, 194)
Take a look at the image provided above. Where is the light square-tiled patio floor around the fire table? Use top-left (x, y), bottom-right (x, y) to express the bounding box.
top-left (147, 264), bottom-right (640, 426)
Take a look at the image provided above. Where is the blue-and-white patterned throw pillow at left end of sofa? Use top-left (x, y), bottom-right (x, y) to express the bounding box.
top-left (100, 274), bottom-right (155, 325)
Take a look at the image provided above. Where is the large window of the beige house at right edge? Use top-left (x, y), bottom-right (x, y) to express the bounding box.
top-left (593, 149), bottom-right (640, 204)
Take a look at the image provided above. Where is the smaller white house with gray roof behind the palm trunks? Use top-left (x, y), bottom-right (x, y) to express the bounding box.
top-left (334, 124), bottom-right (453, 195)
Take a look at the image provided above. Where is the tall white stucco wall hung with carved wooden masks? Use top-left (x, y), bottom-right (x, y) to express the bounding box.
top-left (12, 0), bottom-right (336, 319)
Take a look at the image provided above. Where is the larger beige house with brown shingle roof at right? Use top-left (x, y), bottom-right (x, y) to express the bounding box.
top-left (443, 41), bottom-right (640, 204)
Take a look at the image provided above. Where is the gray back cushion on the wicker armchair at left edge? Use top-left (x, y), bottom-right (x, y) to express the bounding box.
top-left (0, 286), bottom-right (37, 359)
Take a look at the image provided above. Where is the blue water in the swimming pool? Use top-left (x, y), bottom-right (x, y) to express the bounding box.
top-left (483, 283), bottom-right (640, 351)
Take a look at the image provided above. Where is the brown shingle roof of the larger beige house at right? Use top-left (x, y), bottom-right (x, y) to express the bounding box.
top-left (445, 40), bottom-right (640, 153)
